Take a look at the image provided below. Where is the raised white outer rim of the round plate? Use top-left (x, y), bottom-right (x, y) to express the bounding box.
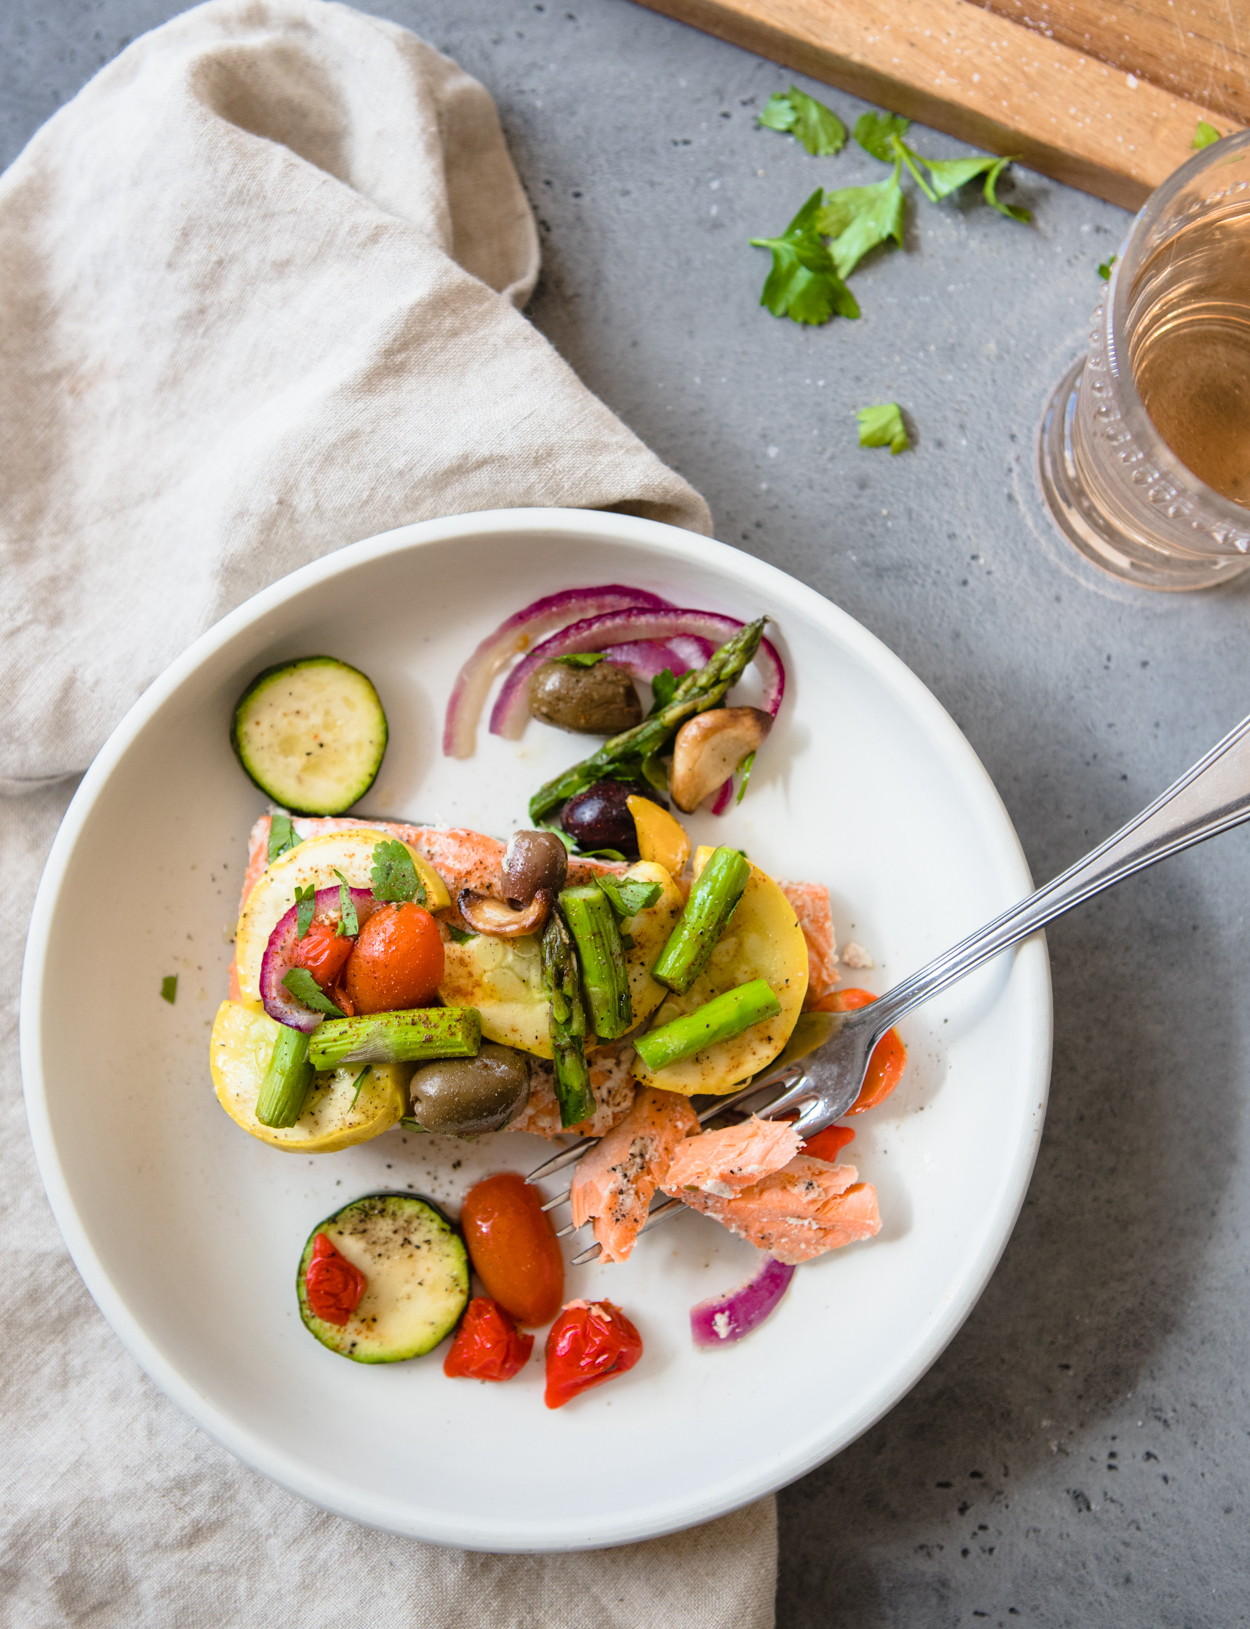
top-left (18, 508), bottom-right (1053, 1552)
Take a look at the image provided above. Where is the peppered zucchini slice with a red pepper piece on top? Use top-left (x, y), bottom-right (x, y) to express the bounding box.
top-left (295, 1194), bottom-right (469, 1363)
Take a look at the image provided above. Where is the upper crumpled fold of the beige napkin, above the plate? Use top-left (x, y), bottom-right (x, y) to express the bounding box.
top-left (0, 0), bottom-right (711, 792)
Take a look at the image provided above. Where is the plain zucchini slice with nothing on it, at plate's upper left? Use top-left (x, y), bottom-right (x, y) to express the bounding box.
top-left (230, 656), bottom-right (386, 815)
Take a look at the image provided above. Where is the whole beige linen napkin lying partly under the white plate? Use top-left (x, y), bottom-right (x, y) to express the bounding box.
top-left (0, 0), bottom-right (776, 1629)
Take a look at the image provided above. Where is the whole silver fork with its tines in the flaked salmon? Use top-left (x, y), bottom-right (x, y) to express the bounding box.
top-left (528, 706), bottom-right (1250, 1266)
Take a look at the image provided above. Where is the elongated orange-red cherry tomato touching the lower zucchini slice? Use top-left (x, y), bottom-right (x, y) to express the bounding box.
top-left (460, 1171), bottom-right (564, 1324)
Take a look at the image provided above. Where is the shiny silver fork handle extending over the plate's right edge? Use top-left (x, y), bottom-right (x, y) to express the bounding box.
top-left (856, 718), bottom-right (1250, 1044)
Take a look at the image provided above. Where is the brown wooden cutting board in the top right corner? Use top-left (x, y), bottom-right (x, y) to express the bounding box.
top-left (642, 0), bottom-right (1250, 209)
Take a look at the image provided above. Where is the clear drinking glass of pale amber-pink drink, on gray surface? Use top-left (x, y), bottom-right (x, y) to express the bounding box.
top-left (1040, 132), bottom-right (1250, 590)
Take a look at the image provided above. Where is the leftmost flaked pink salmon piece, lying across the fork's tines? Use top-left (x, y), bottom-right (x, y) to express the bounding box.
top-left (570, 1087), bottom-right (699, 1261)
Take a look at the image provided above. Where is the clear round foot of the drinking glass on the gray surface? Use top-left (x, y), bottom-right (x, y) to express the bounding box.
top-left (1038, 357), bottom-right (1250, 593)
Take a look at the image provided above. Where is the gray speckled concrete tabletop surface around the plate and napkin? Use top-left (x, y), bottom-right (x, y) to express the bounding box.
top-left (9, 0), bottom-right (1250, 1629)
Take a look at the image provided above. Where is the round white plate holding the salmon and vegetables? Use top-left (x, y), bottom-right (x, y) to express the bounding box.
top-left (21, 510), bottom-right (1050, 1551)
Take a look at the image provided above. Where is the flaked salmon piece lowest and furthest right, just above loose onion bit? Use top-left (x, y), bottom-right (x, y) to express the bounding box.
top-left (665, 1153), bottom-right (882, 1267)
